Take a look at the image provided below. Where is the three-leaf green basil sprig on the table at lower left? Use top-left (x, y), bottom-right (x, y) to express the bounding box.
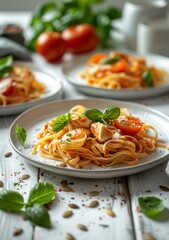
top-left (0, 182), bottom-right (55, 228)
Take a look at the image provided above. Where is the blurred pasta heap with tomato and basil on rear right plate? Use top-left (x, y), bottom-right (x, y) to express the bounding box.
top-left (80, 52), bottom-right (167, 90)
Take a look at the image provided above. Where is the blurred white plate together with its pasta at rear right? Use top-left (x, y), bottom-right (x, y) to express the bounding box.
top-left (63, 51), bottom-right (169, 100)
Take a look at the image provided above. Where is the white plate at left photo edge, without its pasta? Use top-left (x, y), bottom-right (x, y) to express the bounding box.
top-left (0, 62), bottom-right (63, 116)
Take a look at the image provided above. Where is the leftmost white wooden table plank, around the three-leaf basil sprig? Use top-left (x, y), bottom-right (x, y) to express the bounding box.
top-left (0, 117), bottom-right (38, 240)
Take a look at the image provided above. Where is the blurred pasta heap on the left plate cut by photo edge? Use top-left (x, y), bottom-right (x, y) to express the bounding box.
top-left (0, 66), bottom-right (45, 106)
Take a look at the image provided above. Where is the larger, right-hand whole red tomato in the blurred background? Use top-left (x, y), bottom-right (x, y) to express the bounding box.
top-left (62, 23), bottom-right (98, 54)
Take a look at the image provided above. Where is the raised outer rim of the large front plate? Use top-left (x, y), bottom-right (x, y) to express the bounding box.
top-left (8, 98), bottom-right (169, 178)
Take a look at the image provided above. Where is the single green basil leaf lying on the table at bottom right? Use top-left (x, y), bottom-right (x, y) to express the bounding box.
top-left (138, 197), bottom-right (164, 217)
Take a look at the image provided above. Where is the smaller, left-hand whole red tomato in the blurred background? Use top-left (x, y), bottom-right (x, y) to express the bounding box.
top-left (36, 32), bottom-right (66, 62)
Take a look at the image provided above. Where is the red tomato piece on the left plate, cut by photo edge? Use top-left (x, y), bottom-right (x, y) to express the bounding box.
top-left (0, 78), bottom-right (14, 96)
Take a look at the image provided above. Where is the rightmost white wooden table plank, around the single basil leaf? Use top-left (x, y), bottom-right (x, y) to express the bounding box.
top-left (129, 162), bottom-right (169, 240)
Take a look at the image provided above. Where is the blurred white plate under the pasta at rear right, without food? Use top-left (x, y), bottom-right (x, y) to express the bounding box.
top-left (62, 51), bottom-right (169, 100)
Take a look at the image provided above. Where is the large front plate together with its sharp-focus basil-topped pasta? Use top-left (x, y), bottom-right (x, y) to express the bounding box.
top-left (9, 99), bottom-right (169, 178)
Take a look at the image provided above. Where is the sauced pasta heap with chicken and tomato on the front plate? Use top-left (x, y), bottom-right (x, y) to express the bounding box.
top-left (32, 105), bottom-right (167, 168)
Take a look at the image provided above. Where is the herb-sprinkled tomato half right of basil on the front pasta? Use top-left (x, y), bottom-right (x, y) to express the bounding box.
top-left (114, 116), bottom-right (143, 136)
